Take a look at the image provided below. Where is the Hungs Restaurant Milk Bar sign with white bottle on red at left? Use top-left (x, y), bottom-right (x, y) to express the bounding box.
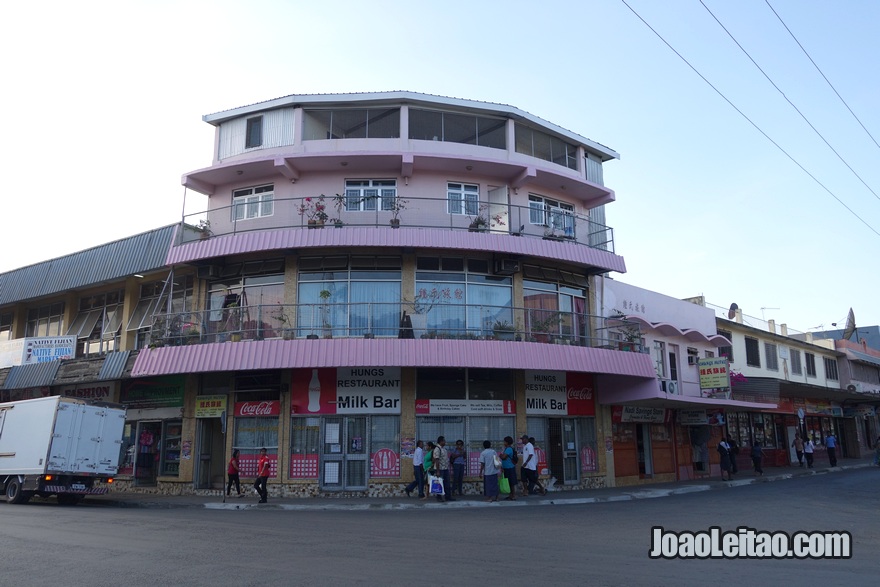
top-left (290, 367), bottom-right (400, 415)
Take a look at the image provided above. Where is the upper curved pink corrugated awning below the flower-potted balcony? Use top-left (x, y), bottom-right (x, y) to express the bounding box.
top-left (166, 227), bottom-right (626, 273)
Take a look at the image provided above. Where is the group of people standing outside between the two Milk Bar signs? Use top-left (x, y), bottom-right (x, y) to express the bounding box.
top-left (404, 434), bottom-right (547, 502)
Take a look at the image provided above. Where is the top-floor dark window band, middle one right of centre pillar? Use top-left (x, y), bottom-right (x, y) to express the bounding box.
top-left (409, 108), bottom-right (507, 149)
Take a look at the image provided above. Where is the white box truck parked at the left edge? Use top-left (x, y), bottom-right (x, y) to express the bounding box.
top-left (0, 396), bottom-right (125, 505)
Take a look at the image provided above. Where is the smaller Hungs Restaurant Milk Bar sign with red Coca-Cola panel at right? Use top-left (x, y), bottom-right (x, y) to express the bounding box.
top-left (525, 369), bottom-right (596, 416)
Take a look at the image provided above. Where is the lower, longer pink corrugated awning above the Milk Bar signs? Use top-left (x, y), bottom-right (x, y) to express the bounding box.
top-left (131, 338), bottom-right (657, 379)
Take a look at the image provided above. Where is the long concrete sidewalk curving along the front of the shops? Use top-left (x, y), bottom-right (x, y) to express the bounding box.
top-left (84, 458), bottom-right (874, 511)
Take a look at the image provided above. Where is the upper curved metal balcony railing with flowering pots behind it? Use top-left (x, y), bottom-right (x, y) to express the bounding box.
top-left (178, 196), bottom-right (614, 253)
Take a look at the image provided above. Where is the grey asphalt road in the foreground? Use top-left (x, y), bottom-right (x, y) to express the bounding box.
top-left (0, 468), bottom-right (880, 587)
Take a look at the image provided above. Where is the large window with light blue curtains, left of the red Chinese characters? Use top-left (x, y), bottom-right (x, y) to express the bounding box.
top-left (297, 256), bottom-right (402, 337)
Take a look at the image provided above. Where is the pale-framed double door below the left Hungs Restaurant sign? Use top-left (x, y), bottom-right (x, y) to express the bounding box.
top-left (320, 416), bottom-right (370, 491)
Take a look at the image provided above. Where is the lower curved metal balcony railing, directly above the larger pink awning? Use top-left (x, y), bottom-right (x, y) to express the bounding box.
top-left (143, 302), bottom-right (642, 352)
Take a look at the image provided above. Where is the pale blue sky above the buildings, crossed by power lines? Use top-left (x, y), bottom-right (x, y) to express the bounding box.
top-left (0, 0), bottom-right (880, 331)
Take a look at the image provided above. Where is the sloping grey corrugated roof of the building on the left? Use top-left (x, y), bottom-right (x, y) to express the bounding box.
top-left (0, 224), bottom-right (178, 305)
